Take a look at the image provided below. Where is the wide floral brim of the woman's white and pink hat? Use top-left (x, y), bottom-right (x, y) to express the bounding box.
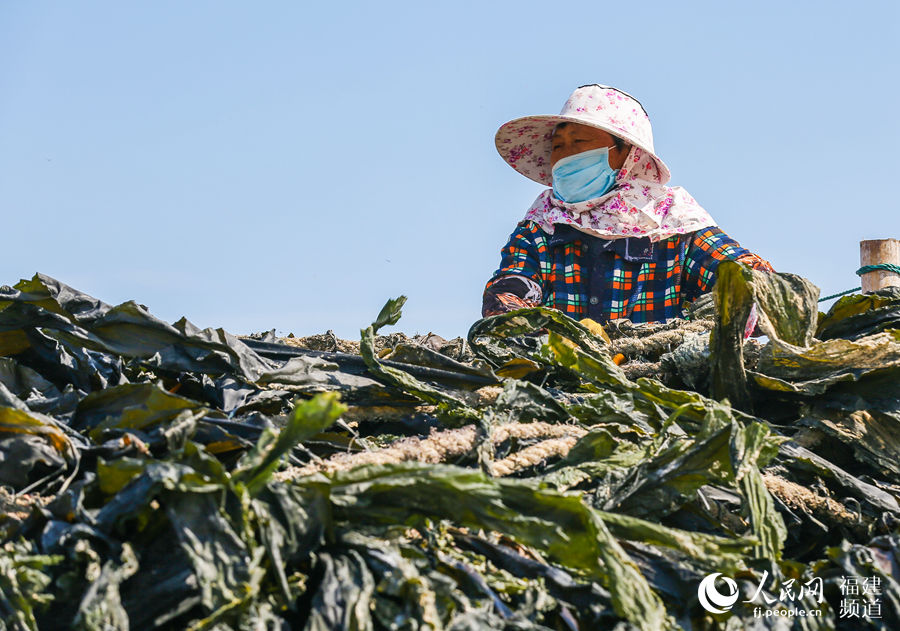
top-left (494, 115), bottom-right (671, 186)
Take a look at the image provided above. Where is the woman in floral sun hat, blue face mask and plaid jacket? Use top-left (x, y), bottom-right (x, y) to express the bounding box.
top-left (482, 85), bottom-right (774, 322)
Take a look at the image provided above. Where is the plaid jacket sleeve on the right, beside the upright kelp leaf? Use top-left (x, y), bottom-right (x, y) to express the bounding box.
top-left (683, 226), bottom-right (775, 301)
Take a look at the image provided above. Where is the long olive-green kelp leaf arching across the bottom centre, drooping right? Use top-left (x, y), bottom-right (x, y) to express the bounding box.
top-left (296, 463), bottom-right (673, 629)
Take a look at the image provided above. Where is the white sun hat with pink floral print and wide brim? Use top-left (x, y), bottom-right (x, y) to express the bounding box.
top-left (494, 84), bottom-right (671, 186)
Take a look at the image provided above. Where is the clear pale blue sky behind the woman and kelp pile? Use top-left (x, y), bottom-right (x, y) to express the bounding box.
top-left (0, 0), bottom-right (900, 338)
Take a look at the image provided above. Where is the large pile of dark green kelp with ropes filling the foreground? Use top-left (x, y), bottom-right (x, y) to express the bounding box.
top-left (0, 262), bottom-right (900, 631)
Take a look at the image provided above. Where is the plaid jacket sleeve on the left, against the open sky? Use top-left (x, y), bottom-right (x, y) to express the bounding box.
top-left (481, 221), bottom-right (547, 317)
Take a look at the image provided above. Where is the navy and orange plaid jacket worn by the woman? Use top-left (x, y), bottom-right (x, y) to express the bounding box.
top-left (482, 221), bottom-right (774, 322)
